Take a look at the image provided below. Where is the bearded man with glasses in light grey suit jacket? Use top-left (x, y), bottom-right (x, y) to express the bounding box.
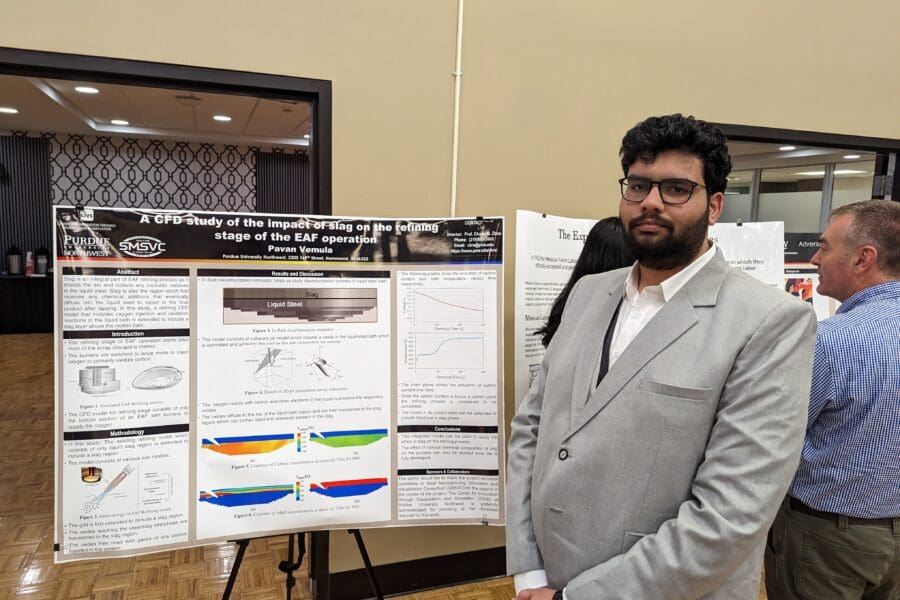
top-left (506, 115), bottom-right (815, 600)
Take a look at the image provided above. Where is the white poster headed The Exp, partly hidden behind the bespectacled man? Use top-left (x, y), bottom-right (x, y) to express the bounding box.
top-left (514, 210), bottom-right (785, 403)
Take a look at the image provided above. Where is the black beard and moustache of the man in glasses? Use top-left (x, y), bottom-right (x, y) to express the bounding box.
top-left (625, 204), bottom-right (709, 271)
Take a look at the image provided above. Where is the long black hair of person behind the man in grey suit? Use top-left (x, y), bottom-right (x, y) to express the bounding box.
top-left (534, 217), bottom-right (634, 348)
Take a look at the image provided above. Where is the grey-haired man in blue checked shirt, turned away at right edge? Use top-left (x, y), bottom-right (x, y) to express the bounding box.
top-left (765, 200), bottom-right (900, 600)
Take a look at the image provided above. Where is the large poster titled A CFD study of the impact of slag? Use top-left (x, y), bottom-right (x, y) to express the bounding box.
top-left (54, 206), bottom-right (505, 562)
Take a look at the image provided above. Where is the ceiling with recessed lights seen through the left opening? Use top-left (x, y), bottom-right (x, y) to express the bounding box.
top-left (0, 75), bottom-right (311, 148)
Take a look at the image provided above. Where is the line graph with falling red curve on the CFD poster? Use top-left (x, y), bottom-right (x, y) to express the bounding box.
top-left (406, 287), bottom-right (485, 325)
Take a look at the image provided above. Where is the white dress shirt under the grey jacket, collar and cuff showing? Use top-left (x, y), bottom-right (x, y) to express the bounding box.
top-left (513, 244), bottom-right (716, 600)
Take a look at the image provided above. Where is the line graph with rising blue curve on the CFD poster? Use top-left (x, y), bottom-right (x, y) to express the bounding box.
top-left (405, 332), bottom-right (484, 371)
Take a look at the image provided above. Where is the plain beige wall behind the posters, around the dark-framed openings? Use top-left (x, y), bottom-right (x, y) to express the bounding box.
top-left (0, 0), bottom-right (900, 570)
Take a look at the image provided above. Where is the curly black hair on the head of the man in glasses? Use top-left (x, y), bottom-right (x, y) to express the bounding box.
top-left (619, 114), bottom-right (731, 194)
